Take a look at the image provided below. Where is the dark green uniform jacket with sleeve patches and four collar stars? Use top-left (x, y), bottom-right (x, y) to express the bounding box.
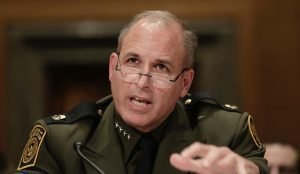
top-left (17, 94), bottom-right (268, 174)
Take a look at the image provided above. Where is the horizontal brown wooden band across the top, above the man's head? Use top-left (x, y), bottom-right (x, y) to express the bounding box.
top-left (0, 0), bottom-right (251, 20)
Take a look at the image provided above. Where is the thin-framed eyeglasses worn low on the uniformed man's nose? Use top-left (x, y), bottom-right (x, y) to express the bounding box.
top-left (115, 53), bottom-right (187, 88)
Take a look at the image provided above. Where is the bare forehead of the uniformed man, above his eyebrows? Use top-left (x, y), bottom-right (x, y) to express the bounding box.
top-left (121, 20), bottom-right (185, 65)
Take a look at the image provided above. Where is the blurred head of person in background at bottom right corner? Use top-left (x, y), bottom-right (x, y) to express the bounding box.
top-left (265, 142), bottom-right (299, 174)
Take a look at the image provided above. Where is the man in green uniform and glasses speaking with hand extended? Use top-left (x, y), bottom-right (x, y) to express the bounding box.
top-left (18, 11), bottom-right (268, 174)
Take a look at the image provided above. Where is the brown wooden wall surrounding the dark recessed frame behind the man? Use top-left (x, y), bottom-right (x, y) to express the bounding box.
top-left (0, 0), bottom-right (300, 166)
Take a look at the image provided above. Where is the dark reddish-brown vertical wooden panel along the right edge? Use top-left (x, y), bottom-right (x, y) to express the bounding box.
top-left (253, 0), bottom-right (300, 145)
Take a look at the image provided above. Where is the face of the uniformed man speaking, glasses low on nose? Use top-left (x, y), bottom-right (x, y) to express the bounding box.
top-left (109, 21), bottom-right (194, 132)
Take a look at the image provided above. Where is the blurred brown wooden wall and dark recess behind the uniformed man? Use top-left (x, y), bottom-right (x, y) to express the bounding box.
top-left (0, 0), bottom-right (300, 171)
